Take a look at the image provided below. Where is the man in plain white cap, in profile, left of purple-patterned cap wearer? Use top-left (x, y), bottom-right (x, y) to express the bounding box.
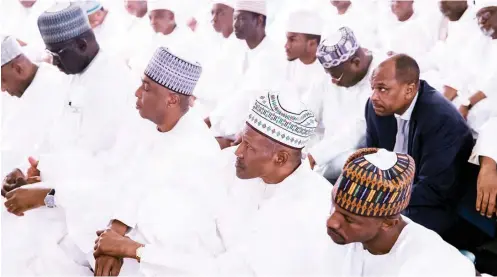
top-left (285, 9), bottom-right (329, 99)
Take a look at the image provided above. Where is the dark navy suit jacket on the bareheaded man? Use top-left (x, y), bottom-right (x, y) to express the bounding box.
top-left (366, 80), bottom-right (477, 234)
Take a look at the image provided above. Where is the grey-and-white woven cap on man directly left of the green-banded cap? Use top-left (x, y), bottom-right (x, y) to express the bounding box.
top-left (145, 47), bottom-right (202, 96)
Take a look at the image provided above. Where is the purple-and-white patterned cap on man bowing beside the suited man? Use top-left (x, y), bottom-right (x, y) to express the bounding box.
top-left (316, 27), bottom-right (360, 68)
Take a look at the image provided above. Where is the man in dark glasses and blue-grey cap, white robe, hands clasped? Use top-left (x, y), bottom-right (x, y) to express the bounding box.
top-left (1, 3), bottom-right (139, 274)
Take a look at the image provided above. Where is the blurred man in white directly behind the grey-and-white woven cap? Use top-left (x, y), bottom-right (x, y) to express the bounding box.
top-left (128, 0), bottom-right (197, 76)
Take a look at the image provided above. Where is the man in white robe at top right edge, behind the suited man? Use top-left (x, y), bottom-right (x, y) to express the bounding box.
top-left (442, 1), bottom-right (497, 138)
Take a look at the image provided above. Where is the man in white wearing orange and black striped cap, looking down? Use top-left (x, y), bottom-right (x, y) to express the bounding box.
top-left (327, 148), bottom-right (476, 277)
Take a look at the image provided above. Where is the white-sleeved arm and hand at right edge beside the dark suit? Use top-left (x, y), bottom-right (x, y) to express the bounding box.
top-left (470, 117), bottom-right (497, 218)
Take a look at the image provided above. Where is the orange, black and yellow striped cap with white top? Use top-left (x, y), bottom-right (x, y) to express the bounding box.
top-left (333, 148), bottom-right (416, 217)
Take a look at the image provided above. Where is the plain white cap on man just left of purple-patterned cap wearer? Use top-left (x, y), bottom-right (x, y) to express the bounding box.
top-left (286, 10), bottom-right (323, 35)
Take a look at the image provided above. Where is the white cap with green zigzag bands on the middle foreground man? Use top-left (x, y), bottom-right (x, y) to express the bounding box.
top-left (247, 90), bottom-right (317, 149)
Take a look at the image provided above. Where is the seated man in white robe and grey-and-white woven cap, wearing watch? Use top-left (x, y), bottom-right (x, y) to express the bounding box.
top-left (5, 48), bottom-right (223, 276)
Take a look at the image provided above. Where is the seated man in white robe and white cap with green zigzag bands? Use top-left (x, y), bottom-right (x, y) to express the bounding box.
top-left (95, 88), bottom-right (331, 276)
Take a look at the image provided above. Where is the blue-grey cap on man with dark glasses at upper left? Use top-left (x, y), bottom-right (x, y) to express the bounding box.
top-left (38, 2), bottom-right (91, 43)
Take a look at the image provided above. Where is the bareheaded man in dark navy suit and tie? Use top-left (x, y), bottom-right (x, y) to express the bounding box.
top-left (366, 54), bottom-right (476, 234)
